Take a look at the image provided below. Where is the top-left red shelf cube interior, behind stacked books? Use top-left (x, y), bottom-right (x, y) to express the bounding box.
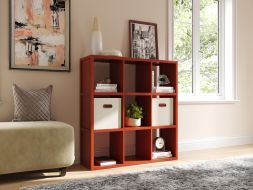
top-left (94, 60), bottom-right (123, 92)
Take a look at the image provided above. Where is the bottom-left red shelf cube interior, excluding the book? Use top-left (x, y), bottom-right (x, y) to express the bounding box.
top-left (94, 132), bottom-right (124, 165)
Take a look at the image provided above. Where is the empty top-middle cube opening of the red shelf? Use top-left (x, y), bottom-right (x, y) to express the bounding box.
top-left (124, 61), bottom-right (152, 92)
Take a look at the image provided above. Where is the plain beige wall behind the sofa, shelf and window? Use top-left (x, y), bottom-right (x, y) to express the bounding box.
top-left (0, 0), bottom-right (253, 163)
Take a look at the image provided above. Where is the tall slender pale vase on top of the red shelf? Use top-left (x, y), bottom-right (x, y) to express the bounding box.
top-left (91, 17), bottom-right (103, 55)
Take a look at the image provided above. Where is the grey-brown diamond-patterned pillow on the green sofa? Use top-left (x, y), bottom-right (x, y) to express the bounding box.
top-left (12, 84), bottom-right (53, 121)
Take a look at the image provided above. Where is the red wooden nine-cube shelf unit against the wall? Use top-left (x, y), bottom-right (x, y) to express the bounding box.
top-left (80, 55), bottom-right (178, 170)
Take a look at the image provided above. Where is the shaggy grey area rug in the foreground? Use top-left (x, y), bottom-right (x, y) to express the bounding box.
top-left (23, 156), bottom-right (253, 190)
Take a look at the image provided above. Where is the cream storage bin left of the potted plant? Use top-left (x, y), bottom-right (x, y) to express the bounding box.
top-left (94, 98), bottom-right (121, 130)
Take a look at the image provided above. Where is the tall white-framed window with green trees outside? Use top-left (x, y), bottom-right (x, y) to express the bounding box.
top-left (169, 0), bottom-right (235, 100)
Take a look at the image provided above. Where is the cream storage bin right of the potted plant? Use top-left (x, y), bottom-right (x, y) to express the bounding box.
top-left (152, 98), bottom-right (173, 126)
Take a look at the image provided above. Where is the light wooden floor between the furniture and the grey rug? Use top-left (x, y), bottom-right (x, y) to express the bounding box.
top-left (0, 145), bottom-right (253, 190)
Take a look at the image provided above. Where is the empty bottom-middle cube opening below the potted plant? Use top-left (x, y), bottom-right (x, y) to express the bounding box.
top-left (125, 130), bottom-right (151, 162)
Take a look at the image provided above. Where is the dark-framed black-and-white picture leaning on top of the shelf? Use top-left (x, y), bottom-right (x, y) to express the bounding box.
top-left (129, 20), bottom-right (159, 59)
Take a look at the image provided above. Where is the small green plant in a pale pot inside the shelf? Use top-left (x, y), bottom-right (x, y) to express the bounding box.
top-left (126, 103), bottom-right (143, 127)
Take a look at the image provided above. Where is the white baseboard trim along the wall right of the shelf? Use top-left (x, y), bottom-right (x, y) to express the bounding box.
top-left (178, 136), bottom-right (253, 152)
